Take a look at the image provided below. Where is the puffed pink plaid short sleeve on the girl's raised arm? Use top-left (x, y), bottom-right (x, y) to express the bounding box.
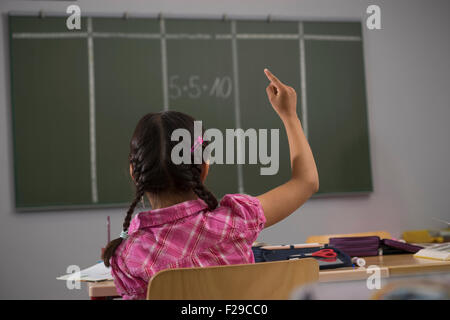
top-left (220, 194), bottom-right (266, 233)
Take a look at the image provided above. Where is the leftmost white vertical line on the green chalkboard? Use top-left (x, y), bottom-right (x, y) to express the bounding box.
top-left (87, 18), bottom-right (98, 203)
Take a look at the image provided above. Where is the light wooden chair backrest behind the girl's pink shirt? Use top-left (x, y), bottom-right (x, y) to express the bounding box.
top-left (147, 258), bottom-right (319, 300)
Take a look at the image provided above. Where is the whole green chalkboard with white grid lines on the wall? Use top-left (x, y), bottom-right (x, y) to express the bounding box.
top-left (9, 16), bottom-right (372, 209)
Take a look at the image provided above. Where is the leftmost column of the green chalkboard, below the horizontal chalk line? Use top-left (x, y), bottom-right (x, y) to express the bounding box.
top-left (11, 28), bottom-right (91, 208)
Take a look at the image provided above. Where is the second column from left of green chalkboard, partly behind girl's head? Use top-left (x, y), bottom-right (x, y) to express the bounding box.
top-left (93, 18), bottom-right (163, 203)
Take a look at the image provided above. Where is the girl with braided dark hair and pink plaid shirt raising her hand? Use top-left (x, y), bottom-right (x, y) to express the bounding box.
top-left (103, 69), bottom-right (319, 299)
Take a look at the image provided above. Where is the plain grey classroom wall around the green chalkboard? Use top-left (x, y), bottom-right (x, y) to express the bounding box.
top-left (0, 0), bottom-right (450, 299)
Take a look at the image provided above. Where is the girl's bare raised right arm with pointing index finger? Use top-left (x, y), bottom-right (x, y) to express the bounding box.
top-left (257, 69), bottom-right (319, 228)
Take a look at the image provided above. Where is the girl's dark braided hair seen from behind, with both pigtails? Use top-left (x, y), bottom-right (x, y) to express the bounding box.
top-left (103, 111), bottom-right (217, 266)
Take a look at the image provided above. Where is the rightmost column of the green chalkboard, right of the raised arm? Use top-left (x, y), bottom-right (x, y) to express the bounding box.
top-left (305, 23), bottom-right (372, 193)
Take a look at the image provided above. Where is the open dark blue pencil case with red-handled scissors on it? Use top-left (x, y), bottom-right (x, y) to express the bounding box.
top-left (252, 245), bottom-right (352, 270)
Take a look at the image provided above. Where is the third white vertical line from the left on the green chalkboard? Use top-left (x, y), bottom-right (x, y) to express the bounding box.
top-left (231, 20), bottom-right (244, 193)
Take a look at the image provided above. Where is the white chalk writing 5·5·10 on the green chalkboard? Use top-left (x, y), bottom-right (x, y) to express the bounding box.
top-left (168, 75), bottom-right (233, 100)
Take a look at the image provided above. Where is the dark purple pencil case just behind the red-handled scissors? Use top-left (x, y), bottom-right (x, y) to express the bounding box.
top-left (329, 236), bottom-right (380, 257)
